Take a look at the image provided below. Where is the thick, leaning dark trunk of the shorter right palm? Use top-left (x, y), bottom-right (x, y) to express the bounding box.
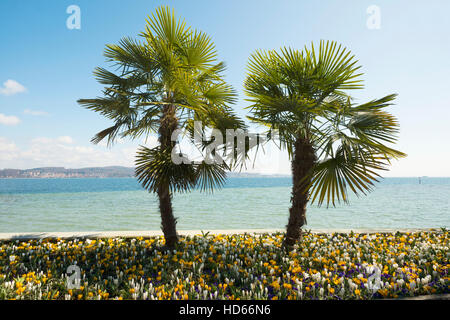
top-left (284, 138), bottom-right (316, 247)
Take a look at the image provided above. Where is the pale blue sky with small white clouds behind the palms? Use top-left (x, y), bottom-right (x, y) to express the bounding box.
top-left (0, 0), bottom-right (450, 176)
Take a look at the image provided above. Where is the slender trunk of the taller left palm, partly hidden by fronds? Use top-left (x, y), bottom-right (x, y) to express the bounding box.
top-left (157, 105), bottom-right (178, 248)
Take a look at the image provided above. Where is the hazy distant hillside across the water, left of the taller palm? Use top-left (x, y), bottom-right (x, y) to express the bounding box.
top-left (0, 166), bottom-right (134, 178)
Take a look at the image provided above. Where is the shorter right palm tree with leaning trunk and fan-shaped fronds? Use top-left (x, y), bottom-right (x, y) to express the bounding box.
top-left (244, 41), bottom-right (406, 248)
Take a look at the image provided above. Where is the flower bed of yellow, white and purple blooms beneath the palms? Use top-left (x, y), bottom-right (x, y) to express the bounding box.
top-left (0, 230), bottom-right (450, 299)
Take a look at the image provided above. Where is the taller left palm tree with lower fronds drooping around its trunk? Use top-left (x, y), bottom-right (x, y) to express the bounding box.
top-left (78, 7), bottom-right (245, 248)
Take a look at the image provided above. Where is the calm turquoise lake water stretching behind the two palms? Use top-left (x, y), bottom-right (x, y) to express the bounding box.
top-left (0, 177), bottom-right (450, 232)
